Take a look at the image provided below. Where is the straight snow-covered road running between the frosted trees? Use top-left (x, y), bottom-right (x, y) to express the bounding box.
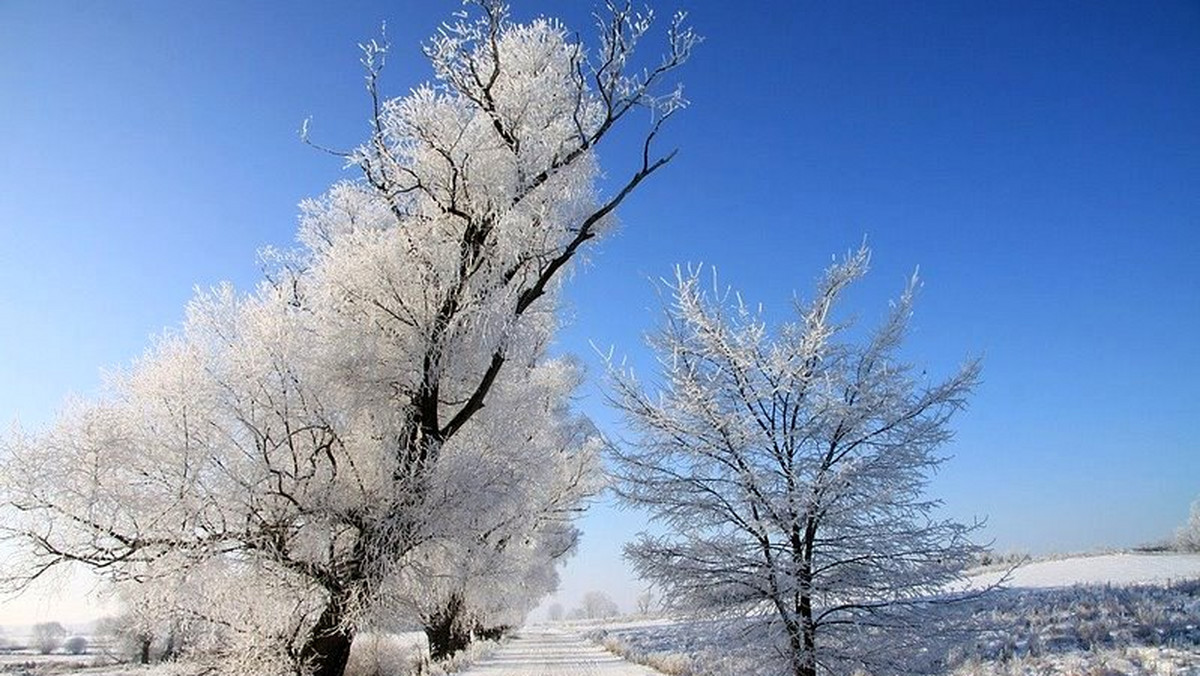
top-left (461, 628), bottom-right (661, 676)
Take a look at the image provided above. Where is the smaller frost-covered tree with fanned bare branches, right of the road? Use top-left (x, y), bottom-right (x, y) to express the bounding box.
top-left (612, 249), bottom-right (979, 676)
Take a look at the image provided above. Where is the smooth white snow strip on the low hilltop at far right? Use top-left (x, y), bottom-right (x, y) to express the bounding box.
top-left (976, 554), bottom-right (1200, 588)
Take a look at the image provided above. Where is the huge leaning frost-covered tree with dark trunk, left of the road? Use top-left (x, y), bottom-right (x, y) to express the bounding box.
top-left (0, 0), bottom-right (696, 676)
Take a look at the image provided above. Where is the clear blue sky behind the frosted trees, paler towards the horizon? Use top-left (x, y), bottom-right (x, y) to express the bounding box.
top-left (0, 0), bottom-right (1200, 619)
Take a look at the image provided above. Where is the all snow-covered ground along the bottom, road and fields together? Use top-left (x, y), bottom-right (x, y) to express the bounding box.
top-left (0, 554), bottom-right (1200, 676)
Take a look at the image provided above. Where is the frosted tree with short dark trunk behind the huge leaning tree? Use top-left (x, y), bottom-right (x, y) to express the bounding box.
top-left (384, 361), bottom-right (600, 658)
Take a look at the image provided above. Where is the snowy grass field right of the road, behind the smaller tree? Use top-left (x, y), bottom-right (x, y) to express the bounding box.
top-left (593, 554), bottom-right (1200, 676)
